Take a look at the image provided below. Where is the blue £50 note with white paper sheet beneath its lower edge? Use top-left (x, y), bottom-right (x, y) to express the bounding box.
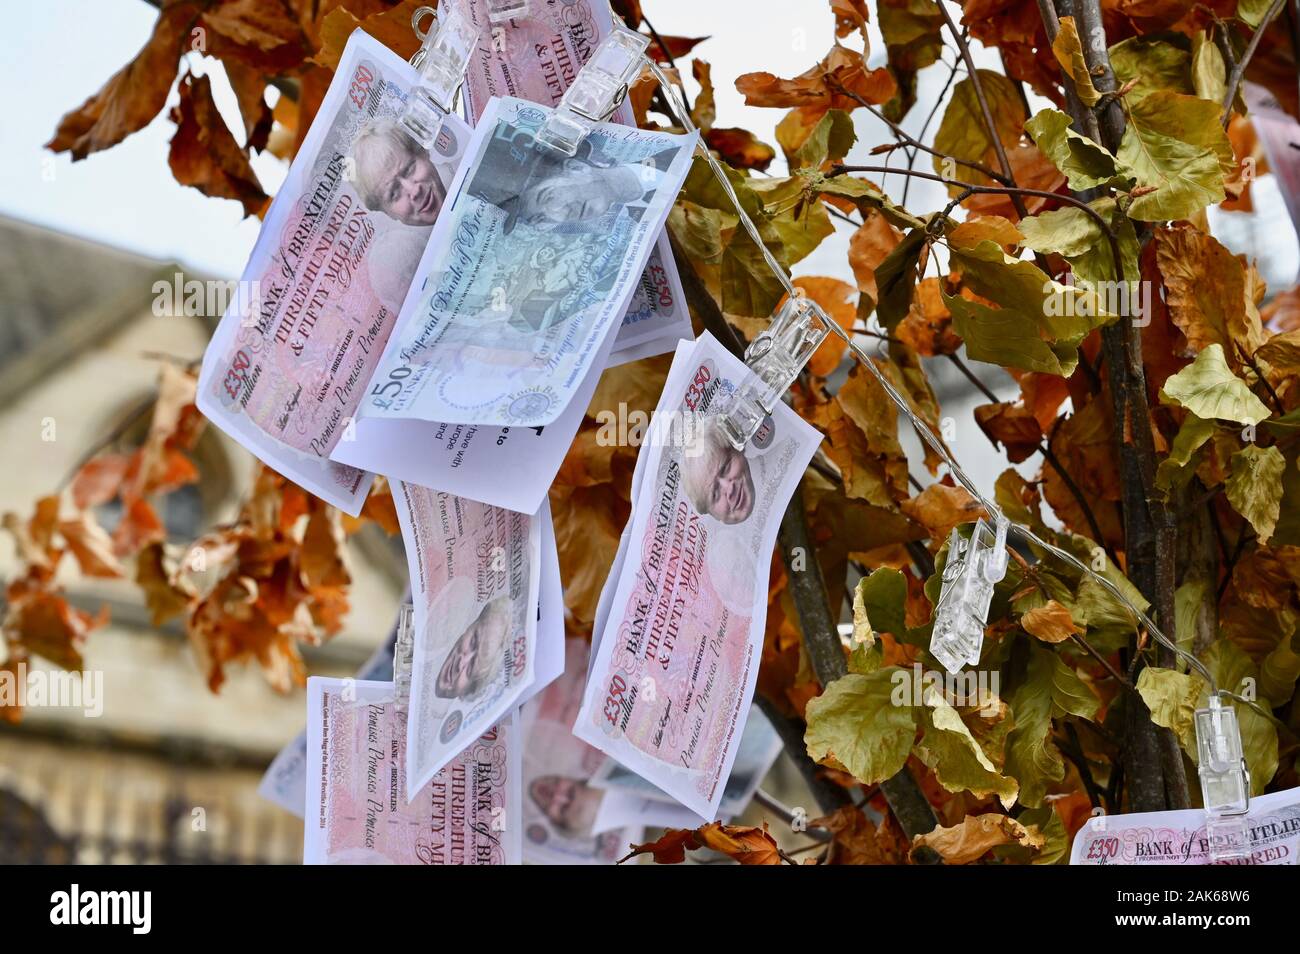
top-left (333, 99), bottom-right (696, 513)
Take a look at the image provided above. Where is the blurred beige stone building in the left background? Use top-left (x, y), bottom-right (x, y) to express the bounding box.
top-left (0, 218), bottom-right (406, 863)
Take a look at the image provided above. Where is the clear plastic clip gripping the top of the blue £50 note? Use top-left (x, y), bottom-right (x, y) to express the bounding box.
top-left (537, 27), bottom-right (650, 156)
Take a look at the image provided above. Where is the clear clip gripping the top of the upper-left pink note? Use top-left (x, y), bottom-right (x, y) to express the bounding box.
top-left (399, 3), bottom-right (478, 149)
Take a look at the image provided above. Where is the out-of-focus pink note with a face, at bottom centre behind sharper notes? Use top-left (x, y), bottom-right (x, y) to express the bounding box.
top-left (519, 639), bottom-right (642, 864)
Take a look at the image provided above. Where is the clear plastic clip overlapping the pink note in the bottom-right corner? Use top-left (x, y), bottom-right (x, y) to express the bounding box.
top-left (1195, 693), bottom-right (1251, 862)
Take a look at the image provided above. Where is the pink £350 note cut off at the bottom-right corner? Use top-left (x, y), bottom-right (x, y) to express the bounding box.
top-left (1070, 789), bottom-right (1300, 864)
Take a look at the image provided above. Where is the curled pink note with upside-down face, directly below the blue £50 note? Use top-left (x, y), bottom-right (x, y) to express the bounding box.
top-left (393, 481), bottom-right (564, 797)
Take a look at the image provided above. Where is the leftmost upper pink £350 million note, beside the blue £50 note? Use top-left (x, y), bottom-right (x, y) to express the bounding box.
top-left (198, 31), bottom-right (469, 515)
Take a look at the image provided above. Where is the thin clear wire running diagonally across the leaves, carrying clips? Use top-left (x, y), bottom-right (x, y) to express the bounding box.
top-left (645, 56), bottom-right (1236, 698)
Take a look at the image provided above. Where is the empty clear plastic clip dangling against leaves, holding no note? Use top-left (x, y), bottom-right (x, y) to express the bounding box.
top-left (930, 515), bottom-right (1010, 673)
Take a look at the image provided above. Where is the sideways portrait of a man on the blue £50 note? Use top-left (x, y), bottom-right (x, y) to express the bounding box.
top-left (469, 125), bottom-right (679, 235)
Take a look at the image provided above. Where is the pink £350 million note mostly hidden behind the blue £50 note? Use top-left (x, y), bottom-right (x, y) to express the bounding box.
top-left (443, 0), bottom-right (693, 367)
